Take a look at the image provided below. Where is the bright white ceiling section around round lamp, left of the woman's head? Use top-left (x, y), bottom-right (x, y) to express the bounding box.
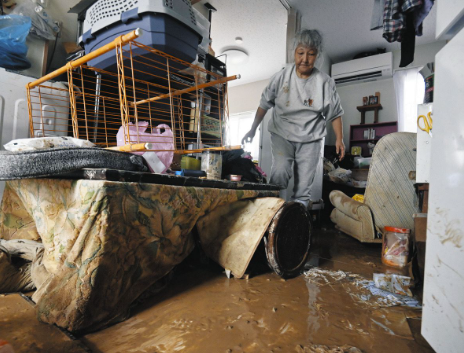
top-left (209, 0), bottom-right (287, 86)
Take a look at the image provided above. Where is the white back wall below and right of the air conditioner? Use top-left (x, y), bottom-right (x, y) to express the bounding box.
top-left (325, 41), bottom-right (446, 149)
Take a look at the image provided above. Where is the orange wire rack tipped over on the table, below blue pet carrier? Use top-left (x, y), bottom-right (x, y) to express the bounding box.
top-left (27, 30), bottom-right (239, 153)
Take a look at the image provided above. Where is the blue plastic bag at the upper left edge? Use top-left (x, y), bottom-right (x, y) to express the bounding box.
top-left (0, 15), bottom-right (31, 70)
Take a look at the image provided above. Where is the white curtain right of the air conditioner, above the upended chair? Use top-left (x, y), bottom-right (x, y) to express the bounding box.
top-left (393, 67), bottom-right (425, 132)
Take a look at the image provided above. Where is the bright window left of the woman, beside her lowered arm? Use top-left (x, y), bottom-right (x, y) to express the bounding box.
top-left (229, 111), bottom-right (261, 160)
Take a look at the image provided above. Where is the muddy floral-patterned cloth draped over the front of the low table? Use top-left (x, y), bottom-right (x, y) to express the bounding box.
top-left (0, 179), bottom-right (278, 331)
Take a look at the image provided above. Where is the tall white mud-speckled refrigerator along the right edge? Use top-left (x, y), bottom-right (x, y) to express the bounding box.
top-left (422, 0), bottom-right (464, 353)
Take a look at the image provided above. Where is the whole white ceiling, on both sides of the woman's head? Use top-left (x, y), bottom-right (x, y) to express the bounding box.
top-left (195, 0), bottom-right (436, 86)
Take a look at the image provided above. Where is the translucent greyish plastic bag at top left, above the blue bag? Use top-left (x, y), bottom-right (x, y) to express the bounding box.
top-left (12, 2), bottom-right (60, 40)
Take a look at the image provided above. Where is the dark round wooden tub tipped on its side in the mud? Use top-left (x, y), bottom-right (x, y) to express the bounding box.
top-left (264, 202), bottom-right (311, 278)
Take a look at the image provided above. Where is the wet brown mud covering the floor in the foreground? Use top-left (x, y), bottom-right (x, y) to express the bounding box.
top-left (0, 229), bottom-right (433, 353)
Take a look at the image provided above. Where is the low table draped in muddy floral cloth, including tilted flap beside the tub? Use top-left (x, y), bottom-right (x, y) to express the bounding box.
top-left (0, 169), bottom-right (284, 332)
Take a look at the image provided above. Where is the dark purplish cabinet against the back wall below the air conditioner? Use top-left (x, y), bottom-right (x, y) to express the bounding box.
top-left (350, 121), bottom-right (398, 157)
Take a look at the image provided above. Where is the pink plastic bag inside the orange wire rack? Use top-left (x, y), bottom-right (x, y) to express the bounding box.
top-left (116, 121), bottom-right (174, 173)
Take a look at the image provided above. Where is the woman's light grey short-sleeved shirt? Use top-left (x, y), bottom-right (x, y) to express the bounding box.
top-left (259, 64), bottom-right (343, 142)
